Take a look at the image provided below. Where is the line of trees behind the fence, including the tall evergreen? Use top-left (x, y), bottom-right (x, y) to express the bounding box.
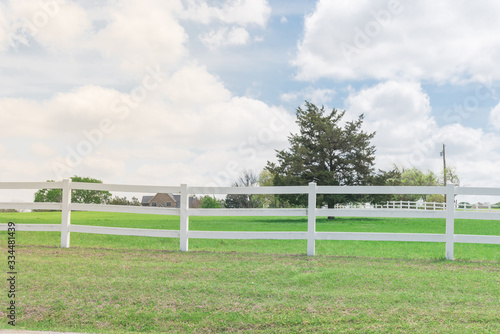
top-left (31, 101), bottom-right (460, 208)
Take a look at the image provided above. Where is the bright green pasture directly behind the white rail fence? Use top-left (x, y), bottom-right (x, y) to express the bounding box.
top-left (0, 212), bottom-right (500, 261)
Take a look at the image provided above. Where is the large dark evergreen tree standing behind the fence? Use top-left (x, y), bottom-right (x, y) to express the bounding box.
top-left (266, 101), bottom-right (375, 207)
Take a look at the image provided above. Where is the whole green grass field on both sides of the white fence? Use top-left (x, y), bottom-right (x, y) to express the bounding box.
top-left (0, 212), bottom-right (500, 333)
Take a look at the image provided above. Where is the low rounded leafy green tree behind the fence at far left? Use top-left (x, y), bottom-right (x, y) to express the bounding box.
top-left (35, 176), bottom-right (111, 204)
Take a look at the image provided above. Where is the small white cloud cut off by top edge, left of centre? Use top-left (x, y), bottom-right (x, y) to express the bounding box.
top-left (183, 0), bottom-right (271, 27)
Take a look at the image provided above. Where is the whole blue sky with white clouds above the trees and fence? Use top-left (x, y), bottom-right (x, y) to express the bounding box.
top-left (0, 0), bottom-right (500, 204)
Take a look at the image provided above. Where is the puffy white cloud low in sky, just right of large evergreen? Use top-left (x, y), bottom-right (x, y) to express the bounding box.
top-left (345, 81), bottom-right (500, 186)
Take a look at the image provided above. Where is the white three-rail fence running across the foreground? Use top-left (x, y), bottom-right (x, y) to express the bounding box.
top-left (0, 180), bottom-right (500, 260)
